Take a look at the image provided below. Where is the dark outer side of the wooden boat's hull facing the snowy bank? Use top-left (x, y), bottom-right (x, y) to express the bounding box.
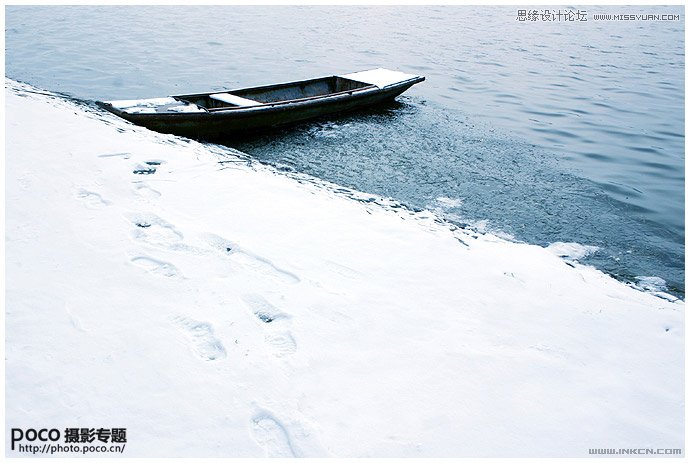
top-left (104, 77), bottom-right (424, 141)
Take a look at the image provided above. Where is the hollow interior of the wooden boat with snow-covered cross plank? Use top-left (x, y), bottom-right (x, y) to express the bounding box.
top-left (175, 76), bottom-right (372, 109)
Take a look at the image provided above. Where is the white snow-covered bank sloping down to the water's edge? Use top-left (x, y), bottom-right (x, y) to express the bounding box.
top-left (5, 81), bottom-right (685, 457)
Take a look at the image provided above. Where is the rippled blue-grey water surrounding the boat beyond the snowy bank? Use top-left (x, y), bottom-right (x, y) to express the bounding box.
top-left (5, 6), bottom-right (685, 295)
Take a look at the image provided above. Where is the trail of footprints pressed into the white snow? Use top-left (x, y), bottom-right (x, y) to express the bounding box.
top-left (86, 153), bottom-right (300, 457)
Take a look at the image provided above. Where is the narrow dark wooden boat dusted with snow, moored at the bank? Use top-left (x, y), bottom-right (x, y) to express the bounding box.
top-left (100, 68), bottom-right (424, 140)
